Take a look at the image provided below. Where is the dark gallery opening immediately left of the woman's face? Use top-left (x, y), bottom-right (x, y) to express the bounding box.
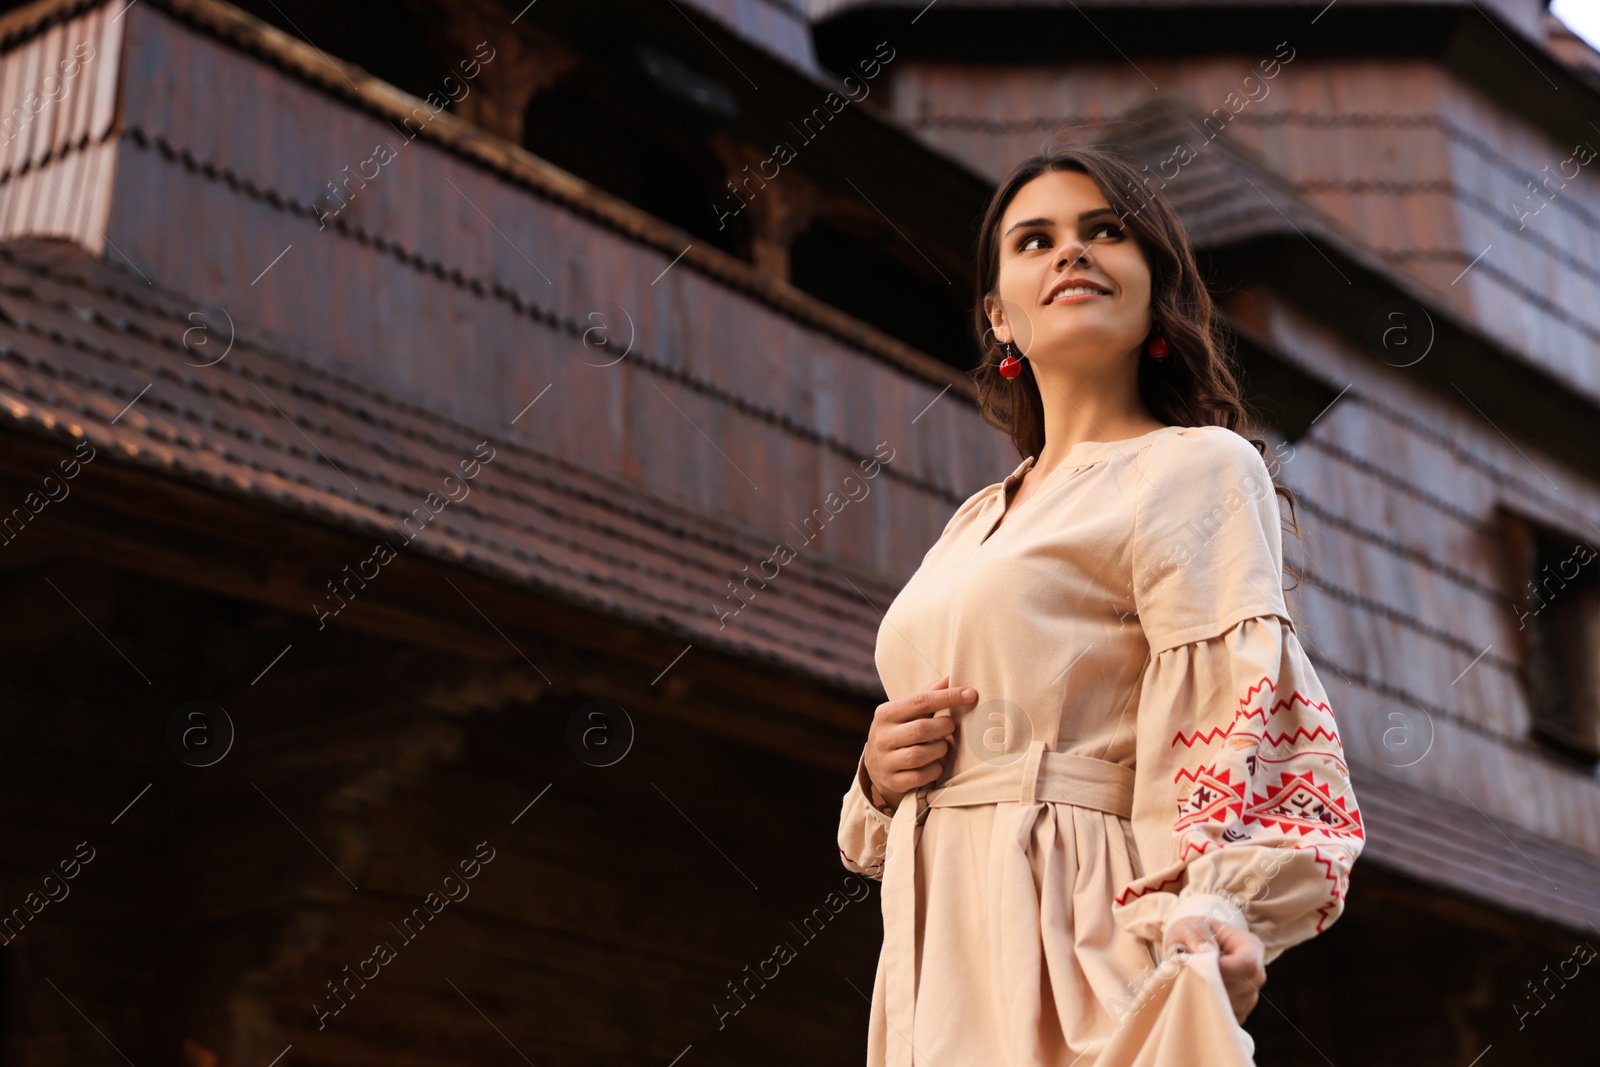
top-left (789, 222), bottom-right (978, 371)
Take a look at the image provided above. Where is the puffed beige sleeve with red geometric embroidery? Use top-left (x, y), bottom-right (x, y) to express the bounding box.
top-left (1114, 427), bottom-right (1363, 961)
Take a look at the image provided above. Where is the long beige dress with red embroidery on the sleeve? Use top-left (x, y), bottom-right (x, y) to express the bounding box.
top-left (838, 426), bottom-right (1363, 1067)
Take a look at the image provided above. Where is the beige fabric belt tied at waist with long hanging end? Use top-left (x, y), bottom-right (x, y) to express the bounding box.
top-left (883, 741), bottom-right (1134, 1067)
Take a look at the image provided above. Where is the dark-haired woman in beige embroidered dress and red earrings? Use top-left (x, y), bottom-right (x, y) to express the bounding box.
top-left (838, 146), bottom-right (1363, 1067)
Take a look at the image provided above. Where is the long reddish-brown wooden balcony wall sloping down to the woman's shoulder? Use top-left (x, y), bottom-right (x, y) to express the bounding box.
top-left (107, 6), bottom-right (1014, 579)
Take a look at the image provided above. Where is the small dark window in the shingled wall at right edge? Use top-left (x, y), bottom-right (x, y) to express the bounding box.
top-left (1507, 515), bottom-right (1600, 769)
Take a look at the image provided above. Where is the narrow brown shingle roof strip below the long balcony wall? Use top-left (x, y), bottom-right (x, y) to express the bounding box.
top-left (0, 240), bottom-right (893, 694)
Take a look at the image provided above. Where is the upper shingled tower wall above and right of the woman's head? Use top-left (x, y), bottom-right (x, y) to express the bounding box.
top-left (890, 56), bottom-right (1600, 412)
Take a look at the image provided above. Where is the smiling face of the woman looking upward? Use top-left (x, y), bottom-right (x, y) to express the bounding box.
top-left (986, 171), bottom-right (1150, 371)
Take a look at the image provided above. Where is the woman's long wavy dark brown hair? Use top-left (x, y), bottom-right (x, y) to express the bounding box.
top-left (973, 142), bottom-right (1301, 581)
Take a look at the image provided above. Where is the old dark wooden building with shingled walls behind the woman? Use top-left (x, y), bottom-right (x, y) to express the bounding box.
top-left (0, 0), bottom-right (1600, 1067)
